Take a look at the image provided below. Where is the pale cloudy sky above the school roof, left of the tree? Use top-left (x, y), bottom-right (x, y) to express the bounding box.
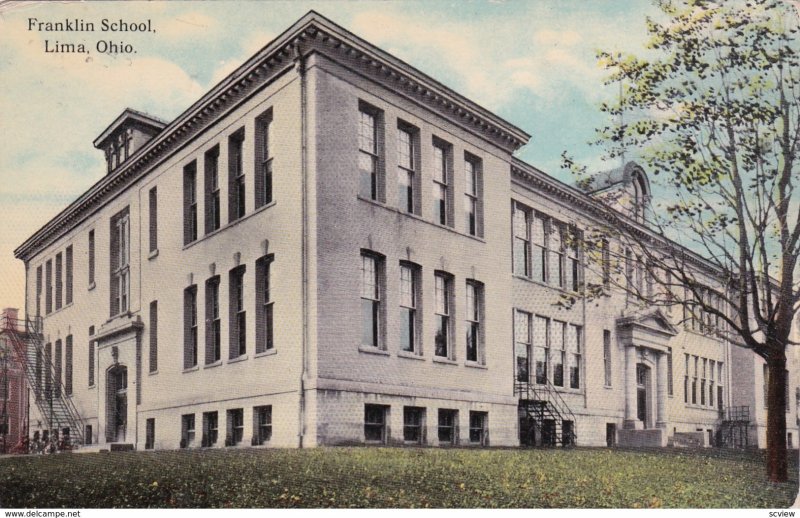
top-left (0, 0), bottom-right (656, 314)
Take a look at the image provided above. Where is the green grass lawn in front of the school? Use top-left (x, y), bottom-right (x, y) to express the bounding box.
top-left (0, 448), bottom-right (798, 508)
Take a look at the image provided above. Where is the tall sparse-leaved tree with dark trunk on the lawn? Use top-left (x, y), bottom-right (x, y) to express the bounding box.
top-left (565, 0), bottom-right (800, 482)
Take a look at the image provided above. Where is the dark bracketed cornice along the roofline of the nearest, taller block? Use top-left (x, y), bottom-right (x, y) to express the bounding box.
top-left (14, 11), bottom-right (530, 262)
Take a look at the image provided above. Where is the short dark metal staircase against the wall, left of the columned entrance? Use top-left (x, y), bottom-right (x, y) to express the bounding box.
top-left (514, 380), bottom-right (578, 447)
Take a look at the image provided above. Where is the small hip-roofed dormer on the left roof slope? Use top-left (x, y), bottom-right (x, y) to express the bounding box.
top-left (94, 108), bottom-right (167, 173)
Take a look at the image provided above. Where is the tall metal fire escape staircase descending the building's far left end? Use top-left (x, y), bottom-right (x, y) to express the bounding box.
top-left (0, 316), bottom-right (85, 449)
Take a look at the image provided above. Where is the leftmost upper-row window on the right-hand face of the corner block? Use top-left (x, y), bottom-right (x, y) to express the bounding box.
top-left (358, 102), bottom-right (383, 201)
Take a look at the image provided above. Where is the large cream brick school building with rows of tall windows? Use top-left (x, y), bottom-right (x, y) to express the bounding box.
top-left (9, 12), bottom-right (798, 449)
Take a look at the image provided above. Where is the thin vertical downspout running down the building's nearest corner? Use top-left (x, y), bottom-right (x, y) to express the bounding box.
top-left (293, 42), bottom-right (309, 448)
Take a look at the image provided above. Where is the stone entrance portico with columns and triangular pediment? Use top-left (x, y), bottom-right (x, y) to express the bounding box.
top-left (617, 309), bottom-right (678, 447)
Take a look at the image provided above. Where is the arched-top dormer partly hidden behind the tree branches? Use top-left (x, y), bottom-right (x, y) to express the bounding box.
top-left (584, 162), bottom-right (652, 223)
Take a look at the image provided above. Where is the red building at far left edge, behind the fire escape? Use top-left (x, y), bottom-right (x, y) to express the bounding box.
top-left (0, 308), bottom-right (28, 453)
